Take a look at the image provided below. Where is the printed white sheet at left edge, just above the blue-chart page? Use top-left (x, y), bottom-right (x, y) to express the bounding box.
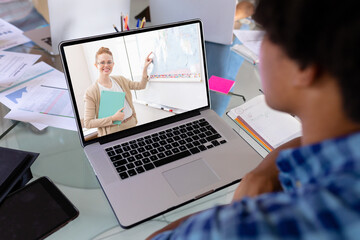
top-left (0, 51), bottom-right (41, 87)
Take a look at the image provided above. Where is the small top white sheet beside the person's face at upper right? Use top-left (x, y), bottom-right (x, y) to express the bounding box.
top-left (234, 30), bottom-right (265, 56)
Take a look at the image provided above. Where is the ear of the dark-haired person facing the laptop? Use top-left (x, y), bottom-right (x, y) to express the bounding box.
top-left (293, 64), bottom-right (320, 87)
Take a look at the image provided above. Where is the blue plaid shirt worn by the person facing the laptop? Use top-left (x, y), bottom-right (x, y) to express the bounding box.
top-left (154, 133), bottom-right (360, 240)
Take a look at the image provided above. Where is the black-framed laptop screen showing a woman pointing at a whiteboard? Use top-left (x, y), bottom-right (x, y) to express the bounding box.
top-left (60, 20), bottom-right (209, 143)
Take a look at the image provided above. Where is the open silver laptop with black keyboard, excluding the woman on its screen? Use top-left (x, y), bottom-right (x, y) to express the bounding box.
top-left (59, 20), bottom-right (262, 228)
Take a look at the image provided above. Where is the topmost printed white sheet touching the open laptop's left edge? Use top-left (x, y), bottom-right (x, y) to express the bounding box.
top-left (5, 85), bottom-right (77, 131)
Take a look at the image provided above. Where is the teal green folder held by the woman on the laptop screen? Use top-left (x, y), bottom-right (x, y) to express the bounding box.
top-left (98, 91), bottom-right (125, 124)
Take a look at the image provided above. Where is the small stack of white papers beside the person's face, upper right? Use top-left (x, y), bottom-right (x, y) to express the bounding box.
top-left (231, 30), bottom-right (265, 65)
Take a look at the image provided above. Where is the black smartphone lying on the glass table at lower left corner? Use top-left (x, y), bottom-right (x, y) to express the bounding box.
top-left (0, 177), bottom-right (79, 239)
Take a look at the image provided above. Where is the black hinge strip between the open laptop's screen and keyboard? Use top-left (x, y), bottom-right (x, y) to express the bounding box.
top-left (99, 110), bottom-right (200, 144)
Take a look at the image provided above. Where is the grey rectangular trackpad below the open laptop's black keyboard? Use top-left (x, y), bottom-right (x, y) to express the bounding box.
top-left (163, 159), bottom-right (220, 197)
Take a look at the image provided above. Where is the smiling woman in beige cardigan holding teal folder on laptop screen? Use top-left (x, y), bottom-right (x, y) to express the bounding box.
top-left (84, 47), bottom-right (152, 137)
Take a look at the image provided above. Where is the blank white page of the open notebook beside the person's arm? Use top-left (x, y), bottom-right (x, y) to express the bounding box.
top-left (228, 95), bottom-right (301, 148)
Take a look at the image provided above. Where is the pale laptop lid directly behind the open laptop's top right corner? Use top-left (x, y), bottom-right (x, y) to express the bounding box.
top-left (150, 0), bottom-right (237, 45)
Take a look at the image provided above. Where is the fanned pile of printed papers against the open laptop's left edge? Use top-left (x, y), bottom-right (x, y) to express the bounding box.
top-left (0, 62), bottom-right (76, 131)
